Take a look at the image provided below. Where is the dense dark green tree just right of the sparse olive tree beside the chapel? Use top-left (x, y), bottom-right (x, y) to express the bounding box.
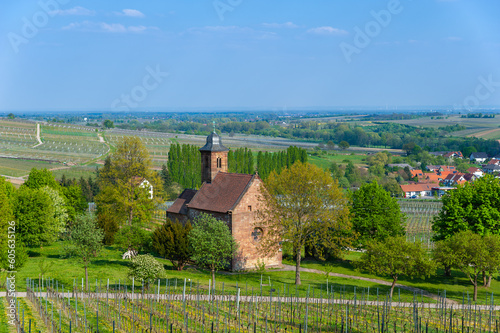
top-left (352, 181), bottom-right (405, 246)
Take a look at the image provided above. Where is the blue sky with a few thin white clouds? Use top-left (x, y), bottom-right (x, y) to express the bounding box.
top-left (0, 0), bottom-right (500, 112)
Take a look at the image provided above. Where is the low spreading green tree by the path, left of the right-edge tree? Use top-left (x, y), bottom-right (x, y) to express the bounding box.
top-left (356, 236), bottom-right (435, 298)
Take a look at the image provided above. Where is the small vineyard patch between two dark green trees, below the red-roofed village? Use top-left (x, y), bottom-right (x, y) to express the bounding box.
top-left (398, 200), bottom-right (442, 247)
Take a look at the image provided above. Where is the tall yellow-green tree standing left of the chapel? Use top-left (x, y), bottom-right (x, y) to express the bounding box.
top-left (96, 137), bottom-right (162, 225)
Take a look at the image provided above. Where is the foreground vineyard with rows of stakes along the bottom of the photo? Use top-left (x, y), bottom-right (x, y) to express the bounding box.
top-left (5, 279), bottom-right (500, 333)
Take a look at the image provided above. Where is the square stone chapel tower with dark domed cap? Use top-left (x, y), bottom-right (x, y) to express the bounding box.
top-left (200, 131), bottom-right (229, 183)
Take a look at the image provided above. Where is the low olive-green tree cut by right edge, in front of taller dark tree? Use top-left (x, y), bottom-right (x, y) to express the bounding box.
top-left (434, 230), bottom-right (500, 301)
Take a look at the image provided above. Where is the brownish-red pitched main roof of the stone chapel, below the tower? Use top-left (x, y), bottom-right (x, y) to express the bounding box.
top-left (189, 172), bottom-right (258, 213)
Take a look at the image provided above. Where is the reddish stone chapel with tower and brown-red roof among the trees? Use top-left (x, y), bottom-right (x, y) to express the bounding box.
top-left (166, 133), bottom-right (282, 271)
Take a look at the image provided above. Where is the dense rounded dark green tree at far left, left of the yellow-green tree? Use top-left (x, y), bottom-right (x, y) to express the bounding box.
top-left (13, 186), bottom-right (60, 246)
